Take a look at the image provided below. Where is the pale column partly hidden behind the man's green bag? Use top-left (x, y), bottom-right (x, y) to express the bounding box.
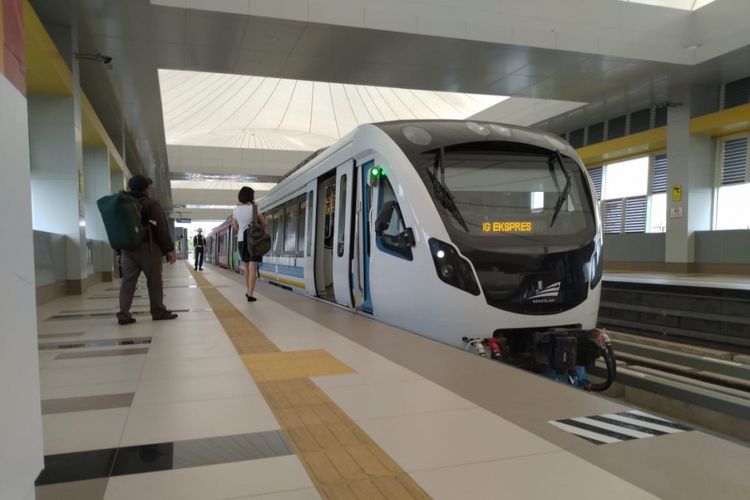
top-left (83, 147), bottom-right (112, 281)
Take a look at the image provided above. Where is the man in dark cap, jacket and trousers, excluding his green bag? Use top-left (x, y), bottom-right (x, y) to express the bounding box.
top-left (117, 175), bottom-right (177, 325)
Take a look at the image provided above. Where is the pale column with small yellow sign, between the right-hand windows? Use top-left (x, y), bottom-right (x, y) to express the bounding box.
top-left (665, 87), bottom-right (714, 272)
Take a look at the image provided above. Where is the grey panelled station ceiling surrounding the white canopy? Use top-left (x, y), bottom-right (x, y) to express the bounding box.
top-left (31, 0), bottom-right (750, 220)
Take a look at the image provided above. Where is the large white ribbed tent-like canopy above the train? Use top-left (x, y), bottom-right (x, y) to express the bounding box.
top-left (159, 69), bottom-right (507, 151)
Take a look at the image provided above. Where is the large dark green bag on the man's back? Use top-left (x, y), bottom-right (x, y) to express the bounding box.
top-left (96, 191), bottom-right (148, 250)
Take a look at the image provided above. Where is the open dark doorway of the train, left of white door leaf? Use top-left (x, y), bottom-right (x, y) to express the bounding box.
top-left (315, 171), bottom-right (336, 302)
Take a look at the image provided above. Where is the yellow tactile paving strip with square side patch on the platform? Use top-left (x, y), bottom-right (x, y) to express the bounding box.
top-left (188, 267), bottom-right (430, 500)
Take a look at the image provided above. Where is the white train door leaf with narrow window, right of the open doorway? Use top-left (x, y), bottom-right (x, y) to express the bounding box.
top-left (333, 160), bottom-right (356, 307)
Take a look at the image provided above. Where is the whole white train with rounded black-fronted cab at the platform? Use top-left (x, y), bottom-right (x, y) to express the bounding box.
top-left (208, 120), bottom-right (615, 390)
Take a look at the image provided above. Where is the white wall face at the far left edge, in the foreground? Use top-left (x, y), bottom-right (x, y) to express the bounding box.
top-left (0, 76), bottom-right (43, 500)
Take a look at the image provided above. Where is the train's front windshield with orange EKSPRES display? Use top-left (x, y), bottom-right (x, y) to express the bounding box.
top-left (416, 143), bottom-right (595, 246)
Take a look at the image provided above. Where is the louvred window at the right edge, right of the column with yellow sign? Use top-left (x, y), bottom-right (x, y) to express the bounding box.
top-left (714, 135), bottom-right (750, 229)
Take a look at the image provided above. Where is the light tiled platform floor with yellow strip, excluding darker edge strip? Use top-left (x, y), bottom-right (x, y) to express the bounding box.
top-left (32, 263), bottom-right (668, 500)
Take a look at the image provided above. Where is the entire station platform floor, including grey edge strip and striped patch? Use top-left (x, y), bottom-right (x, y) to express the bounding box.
top-left (36, 262), bottom-right (750, 500)
